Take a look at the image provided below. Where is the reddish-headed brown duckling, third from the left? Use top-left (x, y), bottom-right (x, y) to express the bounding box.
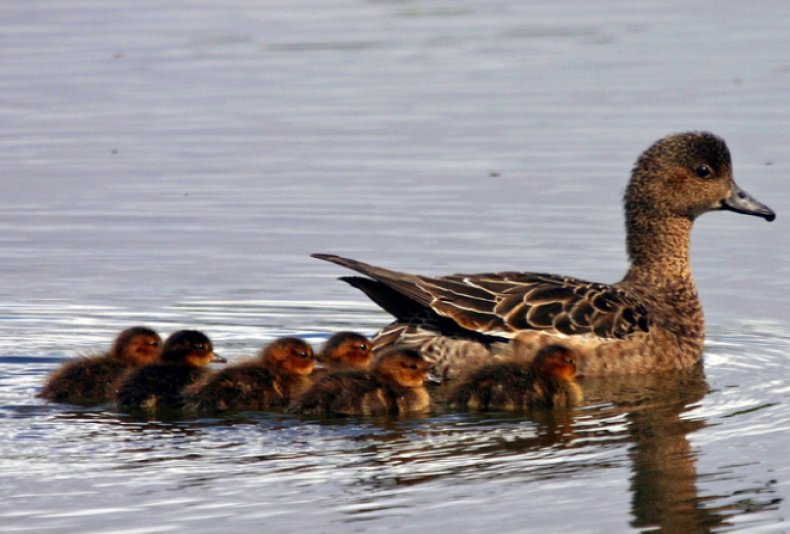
top-left (186, 337), bottom-right (315, 412)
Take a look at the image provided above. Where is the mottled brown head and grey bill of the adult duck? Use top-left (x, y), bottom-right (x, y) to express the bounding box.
top-left (625, 132), bottom-right (776, 226)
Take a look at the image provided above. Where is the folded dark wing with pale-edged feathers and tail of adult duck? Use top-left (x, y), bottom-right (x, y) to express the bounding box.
top-left (313, 254), bottom-right (650, 339)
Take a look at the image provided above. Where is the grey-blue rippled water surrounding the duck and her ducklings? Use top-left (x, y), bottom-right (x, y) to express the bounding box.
top-left (0, 0), bottom-right (790, 533)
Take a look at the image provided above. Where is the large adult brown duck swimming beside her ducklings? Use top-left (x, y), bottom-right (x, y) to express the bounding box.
top-left (313, 131), bottom-right (776, 379)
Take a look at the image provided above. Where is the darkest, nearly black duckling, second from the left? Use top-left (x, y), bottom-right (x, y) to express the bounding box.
top-left (115, 330), bottom-right (227, 412)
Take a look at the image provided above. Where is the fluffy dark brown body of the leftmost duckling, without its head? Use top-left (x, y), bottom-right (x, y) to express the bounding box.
top-left (38, 355), bottom-right (129, 404)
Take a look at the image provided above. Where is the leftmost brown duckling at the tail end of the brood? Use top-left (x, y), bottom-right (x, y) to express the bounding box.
top-left (38, 326), bottom-right (162, 405)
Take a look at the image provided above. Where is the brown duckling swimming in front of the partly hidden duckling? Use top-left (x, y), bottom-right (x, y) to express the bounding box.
top-left (289, 346), bottom-right (431, 415)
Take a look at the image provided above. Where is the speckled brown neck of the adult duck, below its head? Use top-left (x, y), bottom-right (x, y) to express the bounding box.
top-left (623, 217), bottom-right (696, 297)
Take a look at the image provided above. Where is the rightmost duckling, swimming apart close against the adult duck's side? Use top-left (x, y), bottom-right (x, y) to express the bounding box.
top-left (447, 344), bottom-right (583, 411)
